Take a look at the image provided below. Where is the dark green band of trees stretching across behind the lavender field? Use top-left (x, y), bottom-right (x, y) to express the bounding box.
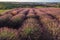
top-left (0, 2), bottom-right (60, 9)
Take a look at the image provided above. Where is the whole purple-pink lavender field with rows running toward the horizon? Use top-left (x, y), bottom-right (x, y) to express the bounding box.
top-left (0, 8), bottom-right (60, 40)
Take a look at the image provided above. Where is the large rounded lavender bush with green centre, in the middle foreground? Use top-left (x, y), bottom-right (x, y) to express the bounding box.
top-left (18, 18), bottom-right (42, 40)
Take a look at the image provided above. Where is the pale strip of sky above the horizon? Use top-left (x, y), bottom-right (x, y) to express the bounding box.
top-left (0, 0), bottom-right (60, 2)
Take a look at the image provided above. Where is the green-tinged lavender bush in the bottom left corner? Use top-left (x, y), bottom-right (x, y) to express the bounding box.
top-left (0, 27), bottom-right (17, 40)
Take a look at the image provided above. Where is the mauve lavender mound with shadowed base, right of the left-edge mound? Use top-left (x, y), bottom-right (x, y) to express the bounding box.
top-left (8, 14), bottom-right (25, 28)
